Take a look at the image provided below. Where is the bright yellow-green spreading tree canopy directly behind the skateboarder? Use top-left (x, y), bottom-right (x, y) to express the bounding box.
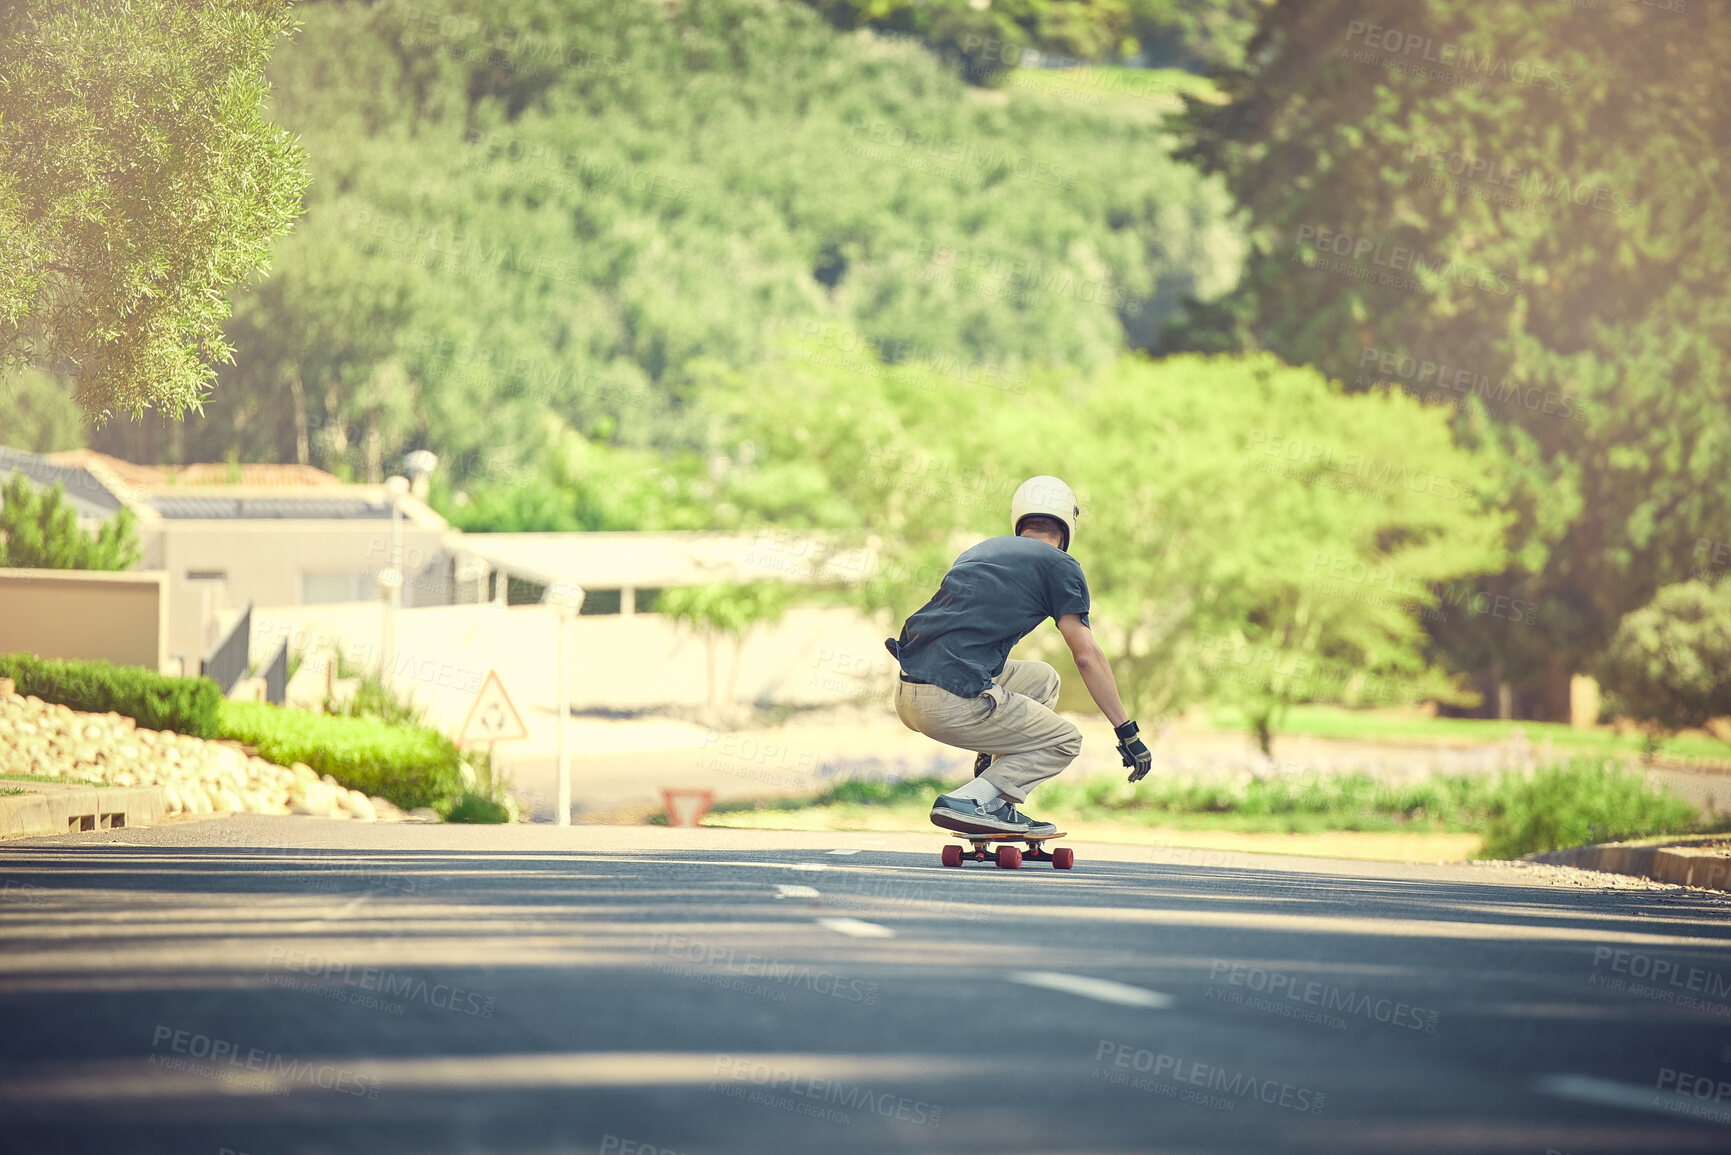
top-left (717, 341), bottom-right (1518, 745)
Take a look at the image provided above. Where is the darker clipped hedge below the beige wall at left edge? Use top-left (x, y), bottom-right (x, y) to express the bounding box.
top-left (0, 653), bottom-right (223, 738)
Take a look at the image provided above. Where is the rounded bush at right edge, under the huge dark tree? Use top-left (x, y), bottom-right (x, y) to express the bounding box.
top-left (1598, 580), bottom-right (1731, 750)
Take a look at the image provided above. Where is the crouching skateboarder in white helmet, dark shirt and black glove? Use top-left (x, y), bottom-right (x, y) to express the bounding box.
top-left (885, 476), bottom-right (1151, 835)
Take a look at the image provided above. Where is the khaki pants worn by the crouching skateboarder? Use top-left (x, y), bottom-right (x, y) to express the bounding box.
top-left (895, 658), bottom-right (1082, 802)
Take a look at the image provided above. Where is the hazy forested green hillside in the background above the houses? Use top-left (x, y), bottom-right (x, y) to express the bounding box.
top-left (87, 0), bottom-right (1239, 491)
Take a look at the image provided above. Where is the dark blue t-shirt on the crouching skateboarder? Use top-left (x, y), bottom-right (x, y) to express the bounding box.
top-left (885, 537), bottom-right (1089, 698)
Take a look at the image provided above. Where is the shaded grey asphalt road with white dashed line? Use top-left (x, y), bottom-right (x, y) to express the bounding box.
top-left (0, 816), bottom-right (1731, 1155)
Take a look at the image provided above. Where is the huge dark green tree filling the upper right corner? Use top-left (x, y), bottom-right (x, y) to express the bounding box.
top-left (1177, 0), bottom-right (1731, 717)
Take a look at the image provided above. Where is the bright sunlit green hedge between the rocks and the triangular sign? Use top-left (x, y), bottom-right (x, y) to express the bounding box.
top-left (220, 701), bottom-right (462, 810)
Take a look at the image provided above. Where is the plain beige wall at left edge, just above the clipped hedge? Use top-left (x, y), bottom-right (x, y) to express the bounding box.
top-left (0, 570), bottom-right (168, 670)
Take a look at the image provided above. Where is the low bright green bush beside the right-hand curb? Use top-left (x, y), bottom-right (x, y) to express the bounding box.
top-left (1480, 758), bottom-right (1700, 859)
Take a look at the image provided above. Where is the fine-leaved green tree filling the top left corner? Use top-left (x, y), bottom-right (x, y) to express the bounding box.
top-left (0, 0), bottom-right (306, 421)
